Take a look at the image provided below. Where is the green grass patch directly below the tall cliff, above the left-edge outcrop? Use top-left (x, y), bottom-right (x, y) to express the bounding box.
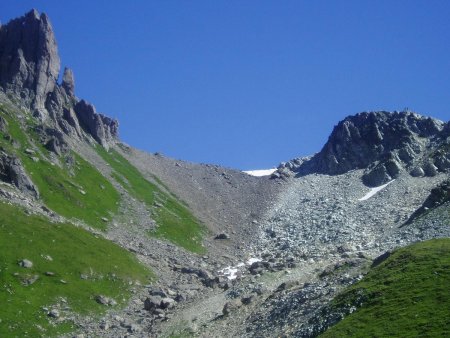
top-left (0, 106), bottom-right (120, 229)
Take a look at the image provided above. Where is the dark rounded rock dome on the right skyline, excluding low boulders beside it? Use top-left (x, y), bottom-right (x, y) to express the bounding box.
top-left (316, 112), bottom-right (443, 175)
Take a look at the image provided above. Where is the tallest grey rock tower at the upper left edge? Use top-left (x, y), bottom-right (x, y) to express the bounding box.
top-left (0, 10), bottom-right (60, 119)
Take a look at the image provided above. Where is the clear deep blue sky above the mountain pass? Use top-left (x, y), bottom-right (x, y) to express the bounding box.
top-left (0, 0), bottom-right (450, 169)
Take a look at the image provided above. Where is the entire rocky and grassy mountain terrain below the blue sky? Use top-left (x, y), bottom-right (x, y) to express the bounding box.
top-left (0, 10), bottom-right (450, 337)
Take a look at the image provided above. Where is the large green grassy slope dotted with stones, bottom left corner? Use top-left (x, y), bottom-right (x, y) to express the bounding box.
top-left (0, 203), bottom-right (151, 337)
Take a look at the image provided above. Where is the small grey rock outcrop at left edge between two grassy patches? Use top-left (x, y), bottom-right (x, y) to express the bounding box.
top-left (0, 152), bottom-right (39, 198)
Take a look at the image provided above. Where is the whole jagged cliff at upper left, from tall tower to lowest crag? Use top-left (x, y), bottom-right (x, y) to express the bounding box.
top-left (0, 10), bottom-right (118, 146)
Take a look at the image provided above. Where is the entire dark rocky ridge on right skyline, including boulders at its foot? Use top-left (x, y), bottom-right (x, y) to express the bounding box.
top-left (277, 111), bottom-right (450, 186)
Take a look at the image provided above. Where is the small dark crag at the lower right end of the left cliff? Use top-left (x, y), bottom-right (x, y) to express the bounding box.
top-left (75, 100), bottom-right (119, 146)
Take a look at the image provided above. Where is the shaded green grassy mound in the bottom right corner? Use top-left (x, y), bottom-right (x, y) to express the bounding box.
top-left (321, 239), bottom-right (450, 337)
